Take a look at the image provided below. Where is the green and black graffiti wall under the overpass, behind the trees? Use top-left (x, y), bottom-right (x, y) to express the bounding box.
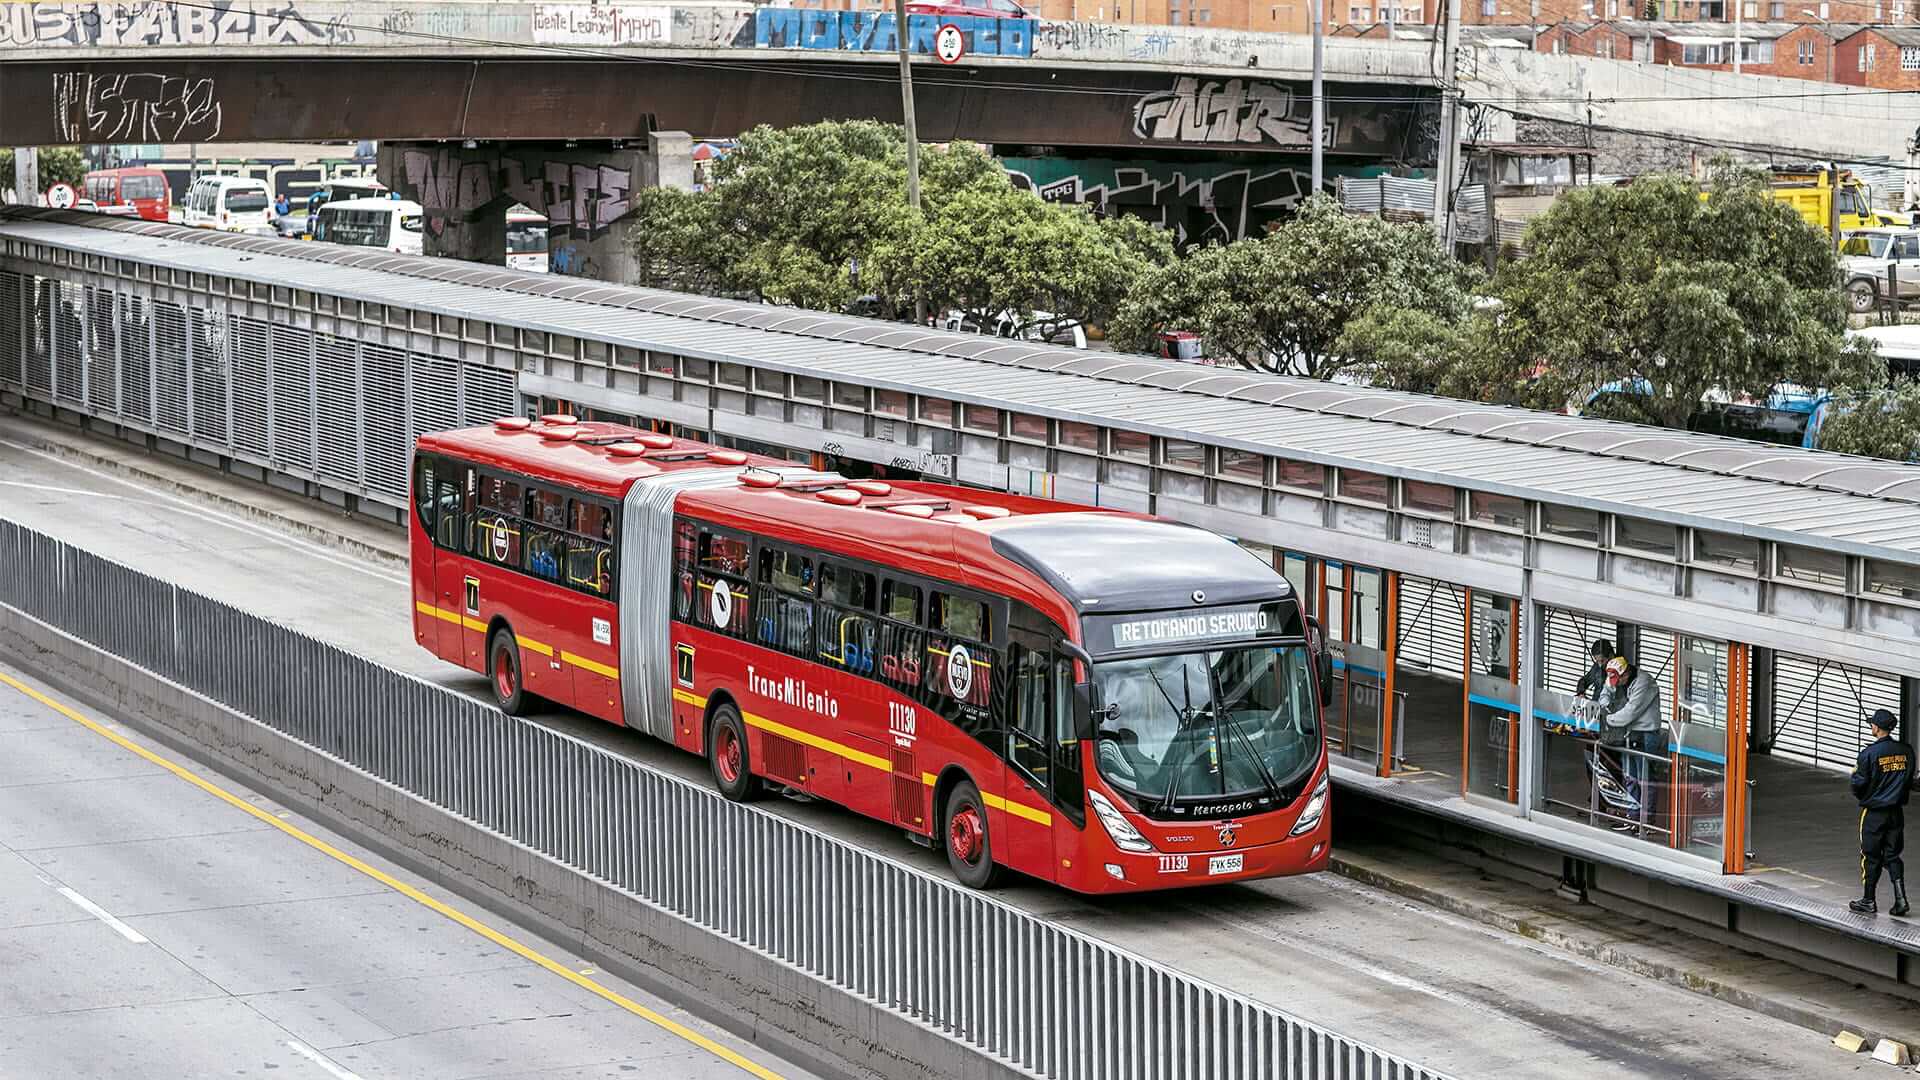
top-left (1000, 158), bottom-right (1375, 246)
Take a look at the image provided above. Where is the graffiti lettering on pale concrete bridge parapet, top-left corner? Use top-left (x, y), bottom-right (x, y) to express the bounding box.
top-left (0, 0), bottom-right (355, 48)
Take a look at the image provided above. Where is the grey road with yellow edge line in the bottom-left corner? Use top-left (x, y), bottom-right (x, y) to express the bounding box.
top-left (0, 665), bottom-right (808, 1080)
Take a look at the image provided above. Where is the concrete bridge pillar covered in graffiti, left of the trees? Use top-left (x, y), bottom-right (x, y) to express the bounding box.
top-left (380, 131), bottom-right (693, 281)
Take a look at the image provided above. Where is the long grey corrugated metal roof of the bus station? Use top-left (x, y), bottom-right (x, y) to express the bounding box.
top-left (11, 208), bottom-right (1920, 563)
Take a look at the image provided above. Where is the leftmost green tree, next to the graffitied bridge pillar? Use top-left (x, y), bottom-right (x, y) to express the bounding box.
top-left (628, 121), bottom-right (1006, 309)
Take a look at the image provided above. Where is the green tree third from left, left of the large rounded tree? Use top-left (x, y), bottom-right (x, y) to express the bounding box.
top-left (1108, 196), bottom-right (1475, 386)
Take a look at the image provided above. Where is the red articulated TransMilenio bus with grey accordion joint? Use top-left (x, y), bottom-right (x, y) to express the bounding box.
top-left (411, 415), bottom-right (1331, 892)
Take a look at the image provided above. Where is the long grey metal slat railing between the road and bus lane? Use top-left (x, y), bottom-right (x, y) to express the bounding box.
top-left (0, 521), bottom-right (1444, 1080)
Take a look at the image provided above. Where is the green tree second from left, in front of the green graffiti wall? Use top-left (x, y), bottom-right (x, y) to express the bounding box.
top-left (870, 179), bottom-right (1173, 336)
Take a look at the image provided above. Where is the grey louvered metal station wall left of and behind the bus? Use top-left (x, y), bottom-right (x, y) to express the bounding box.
top-left (0, 271), bottom-right (520, 507)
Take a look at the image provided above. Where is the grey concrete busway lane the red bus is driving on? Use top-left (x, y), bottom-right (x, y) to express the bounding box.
top-left (0, 409), bottom-right (1920, 1078)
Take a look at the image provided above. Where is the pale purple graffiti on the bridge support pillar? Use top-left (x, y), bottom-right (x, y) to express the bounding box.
top-left (396, 150), bottom-right (634, 240)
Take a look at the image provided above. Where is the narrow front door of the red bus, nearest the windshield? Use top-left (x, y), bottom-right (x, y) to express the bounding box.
top-left (1000, 634), bottom-right (1058, 880)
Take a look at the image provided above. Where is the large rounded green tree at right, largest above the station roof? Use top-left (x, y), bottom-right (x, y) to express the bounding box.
top-left (1448, 167), bottom-right (1884, 427)
